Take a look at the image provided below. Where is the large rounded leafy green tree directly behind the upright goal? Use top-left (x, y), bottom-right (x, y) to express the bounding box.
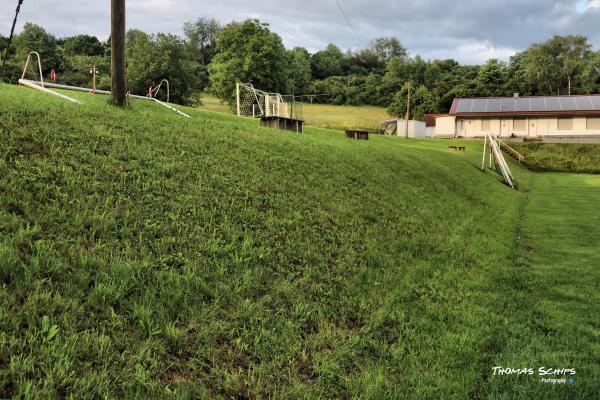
top-left (208, 19), bottom-right (289, 105)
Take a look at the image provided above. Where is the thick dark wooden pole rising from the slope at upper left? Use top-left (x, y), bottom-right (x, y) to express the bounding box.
top-left (110, 0), bottom-right (127, 106)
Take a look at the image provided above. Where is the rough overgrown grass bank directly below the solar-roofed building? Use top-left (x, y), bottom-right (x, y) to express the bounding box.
top-left (510, 143), bottom-right (600, 174)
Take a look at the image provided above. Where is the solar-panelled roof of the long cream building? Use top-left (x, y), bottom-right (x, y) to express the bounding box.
top-left (454, 95), bottom-right (600, 113)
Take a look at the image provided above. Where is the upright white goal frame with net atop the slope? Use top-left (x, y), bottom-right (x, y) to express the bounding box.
top-left (236, 83), bottom-right (302, 120)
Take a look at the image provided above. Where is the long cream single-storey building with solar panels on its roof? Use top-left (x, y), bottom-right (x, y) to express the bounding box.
top-left (425, 95), bottom-right (600, 139)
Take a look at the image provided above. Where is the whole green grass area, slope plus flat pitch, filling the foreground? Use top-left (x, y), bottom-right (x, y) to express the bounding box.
top-left (0, 85), bottom-right (600, 399)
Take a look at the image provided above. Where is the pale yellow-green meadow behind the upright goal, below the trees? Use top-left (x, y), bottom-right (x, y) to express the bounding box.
top-left (201, 95), bottom-right (391, 130)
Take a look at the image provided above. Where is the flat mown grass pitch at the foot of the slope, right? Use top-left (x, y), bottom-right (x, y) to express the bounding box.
top-left (490, 173), bottom-right (600, 399)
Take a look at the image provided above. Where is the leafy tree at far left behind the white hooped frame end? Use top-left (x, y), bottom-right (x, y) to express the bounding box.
top-left (15, 22), bottom-right (61, 73)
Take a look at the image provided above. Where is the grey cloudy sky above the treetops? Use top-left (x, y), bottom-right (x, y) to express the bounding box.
top-left (0, 0), bottom-right (600, 63)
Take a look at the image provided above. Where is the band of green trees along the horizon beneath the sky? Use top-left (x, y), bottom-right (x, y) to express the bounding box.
top-left (0, 18), bottom-right (600, 119)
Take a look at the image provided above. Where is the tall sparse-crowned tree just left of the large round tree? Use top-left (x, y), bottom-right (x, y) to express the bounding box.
top-left (183, 18), bottom-right (222, 65)
